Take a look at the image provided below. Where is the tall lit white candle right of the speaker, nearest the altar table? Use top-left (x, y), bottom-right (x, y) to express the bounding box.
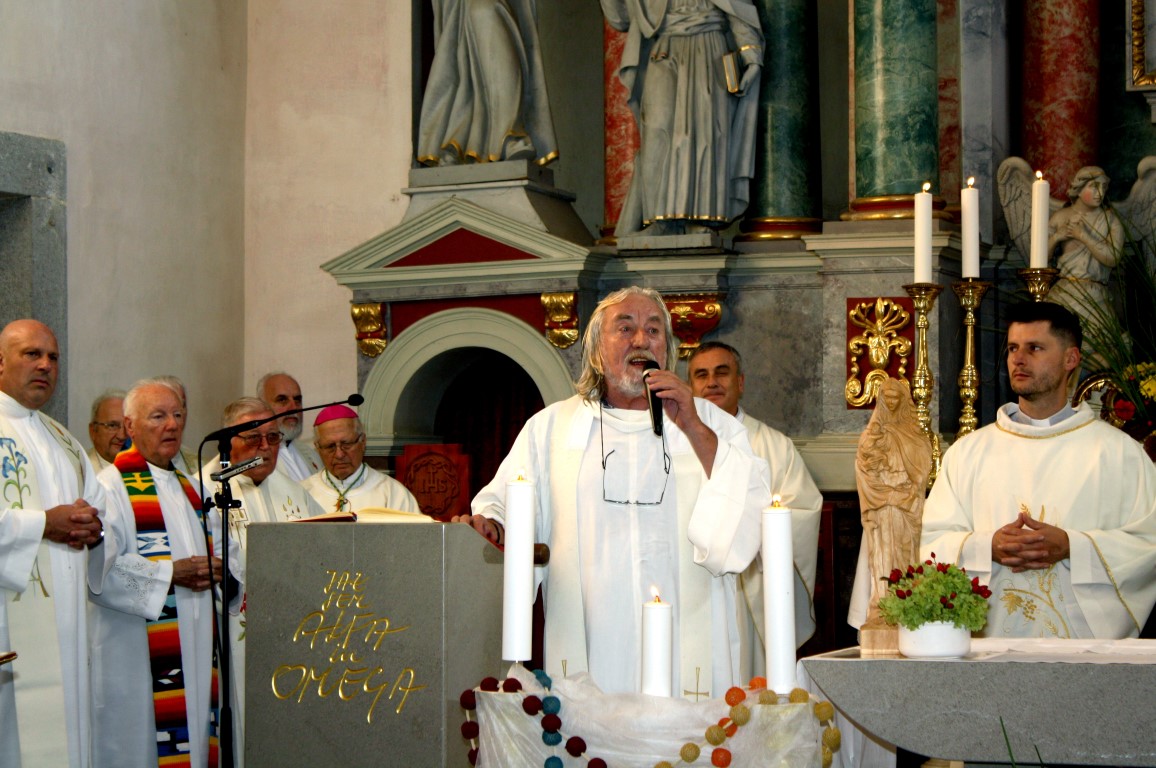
top-left (762, 496), bottom-right (795, 694)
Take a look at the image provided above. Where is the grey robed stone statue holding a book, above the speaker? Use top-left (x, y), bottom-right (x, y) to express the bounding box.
top-left (601, 0), bottom-right (763, 236)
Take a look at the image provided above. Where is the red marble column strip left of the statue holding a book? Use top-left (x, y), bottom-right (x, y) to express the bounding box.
top-left (599, 19), bottom-right (638, 242)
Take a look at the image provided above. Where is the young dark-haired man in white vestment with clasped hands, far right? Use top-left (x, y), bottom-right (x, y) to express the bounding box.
top-left (920, 302), bottom-right (1156, 638)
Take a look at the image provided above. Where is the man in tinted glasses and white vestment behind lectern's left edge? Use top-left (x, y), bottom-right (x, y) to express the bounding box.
top-left (201, 398), bottom-right (325, 768)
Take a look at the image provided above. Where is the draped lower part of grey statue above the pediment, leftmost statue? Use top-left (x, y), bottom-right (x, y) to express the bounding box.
top-left (417, 0), bottom-right (558, 165)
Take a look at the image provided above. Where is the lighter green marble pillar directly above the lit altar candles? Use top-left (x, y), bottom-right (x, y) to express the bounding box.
top-left (854, 0), bottom-right (939, 198)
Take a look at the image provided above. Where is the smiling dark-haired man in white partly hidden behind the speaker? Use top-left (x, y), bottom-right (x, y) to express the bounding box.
top-left (687, 341), bottom-right (823, 680)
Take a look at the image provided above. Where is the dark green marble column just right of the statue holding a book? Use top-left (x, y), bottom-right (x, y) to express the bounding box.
top-left (735, 0), bottom-right (823, 242)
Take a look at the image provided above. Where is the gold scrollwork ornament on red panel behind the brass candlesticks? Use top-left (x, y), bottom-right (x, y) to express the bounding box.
top-left (843, 296), bottom-right (911, 408)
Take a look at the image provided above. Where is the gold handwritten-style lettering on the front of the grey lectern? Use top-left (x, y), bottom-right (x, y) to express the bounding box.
top-left (272, 570), bottom-right (425, 723)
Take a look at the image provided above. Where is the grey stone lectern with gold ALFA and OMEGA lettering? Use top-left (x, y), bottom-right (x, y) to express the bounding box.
top-left (245, 523), bottom-right (505, 768)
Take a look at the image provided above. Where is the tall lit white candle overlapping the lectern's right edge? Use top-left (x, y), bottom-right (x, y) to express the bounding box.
top-left (502, 475), bottom-right (534, 662)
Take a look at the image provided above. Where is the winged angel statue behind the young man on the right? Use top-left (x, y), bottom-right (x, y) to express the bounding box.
top-left (998, 157), bottom-right (1156, 360)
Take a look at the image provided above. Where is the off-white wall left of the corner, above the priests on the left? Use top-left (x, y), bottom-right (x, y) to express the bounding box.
top-left (0, 0), bottom-right (245, 443)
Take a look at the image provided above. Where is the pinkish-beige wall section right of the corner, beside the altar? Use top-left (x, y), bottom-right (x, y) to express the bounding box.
top-left (245, 0), bottom-right (413, 432)
